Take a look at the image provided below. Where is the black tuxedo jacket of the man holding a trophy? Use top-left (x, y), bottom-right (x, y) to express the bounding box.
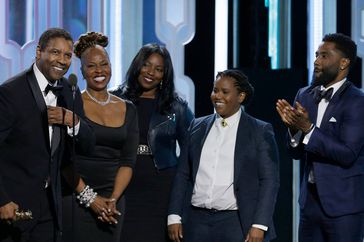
top-left (0, 67), bottom-right (94, 234)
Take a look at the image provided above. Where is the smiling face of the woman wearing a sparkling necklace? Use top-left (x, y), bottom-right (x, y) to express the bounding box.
top-left (81, 45), bottom-right (111, 91)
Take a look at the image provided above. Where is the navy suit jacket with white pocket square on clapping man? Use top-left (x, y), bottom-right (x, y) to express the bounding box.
top-left (288, 81), bottom-right (364, 216)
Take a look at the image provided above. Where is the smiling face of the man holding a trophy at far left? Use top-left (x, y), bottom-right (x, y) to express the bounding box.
top-left (36, 37), bottom-right (73, 82)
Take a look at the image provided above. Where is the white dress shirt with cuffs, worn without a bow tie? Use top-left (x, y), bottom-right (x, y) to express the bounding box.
top-left (168, 109), bottom-right (268, 231)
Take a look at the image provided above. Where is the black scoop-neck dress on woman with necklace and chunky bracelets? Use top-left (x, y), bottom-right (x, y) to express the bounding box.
top-left (63, 102), bottom-right (139, 242)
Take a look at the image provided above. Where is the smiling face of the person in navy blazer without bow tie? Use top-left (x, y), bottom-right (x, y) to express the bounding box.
top-left (211, 76), bottom-right (245, 118)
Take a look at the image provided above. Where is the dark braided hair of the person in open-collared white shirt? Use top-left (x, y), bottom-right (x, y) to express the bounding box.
top-left (216, 69), bottom-right (254, 105)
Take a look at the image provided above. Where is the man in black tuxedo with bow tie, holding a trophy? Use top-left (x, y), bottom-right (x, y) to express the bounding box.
top-left (0, 28), bottom-right (94, 242)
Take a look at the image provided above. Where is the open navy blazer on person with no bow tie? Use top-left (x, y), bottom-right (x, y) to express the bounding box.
top-left (169, 111), bottom-right (279, 241)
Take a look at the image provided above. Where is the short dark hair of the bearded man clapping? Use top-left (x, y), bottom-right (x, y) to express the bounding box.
top-left (322, 33), bottom-right (357, 66)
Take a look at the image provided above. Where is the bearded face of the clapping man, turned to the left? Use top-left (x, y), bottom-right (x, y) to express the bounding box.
top-left (312, 42), bottom-right (350, 87)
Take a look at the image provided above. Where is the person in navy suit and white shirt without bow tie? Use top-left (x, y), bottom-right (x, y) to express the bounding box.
top-left (168, 70), bottom-right (279, 242)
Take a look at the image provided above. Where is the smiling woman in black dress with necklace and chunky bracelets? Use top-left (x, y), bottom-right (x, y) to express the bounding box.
top-left (64, 32), bottom-right (139, 242)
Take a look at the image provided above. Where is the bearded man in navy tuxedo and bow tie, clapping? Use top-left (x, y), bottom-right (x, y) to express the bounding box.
top-left (277, 34), bottom-right (364, 242)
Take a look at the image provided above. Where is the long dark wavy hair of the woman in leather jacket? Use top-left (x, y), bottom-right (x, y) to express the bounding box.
top-left (121, 43), bottom-right (177, 113)
